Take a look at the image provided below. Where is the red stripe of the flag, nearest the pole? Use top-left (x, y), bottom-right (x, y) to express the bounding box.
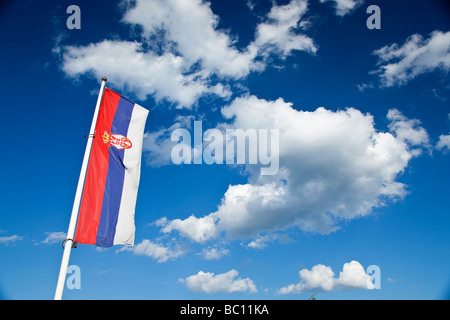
top-left (75, 89), bottom-right (120, 244)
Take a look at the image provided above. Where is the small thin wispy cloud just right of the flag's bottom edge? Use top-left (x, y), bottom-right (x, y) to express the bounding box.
top-left (117, 239), bottom-right (185, 262)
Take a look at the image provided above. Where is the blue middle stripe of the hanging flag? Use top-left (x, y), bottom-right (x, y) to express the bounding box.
top-left (96, 97), bottom-right (134, 247)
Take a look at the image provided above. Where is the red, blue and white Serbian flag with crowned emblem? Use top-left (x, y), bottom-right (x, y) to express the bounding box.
top-left (75, 89), bottom-right (148, 247)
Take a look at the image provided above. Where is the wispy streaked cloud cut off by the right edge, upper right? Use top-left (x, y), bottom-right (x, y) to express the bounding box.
top-left (374, 31), bottom-right (450, 87)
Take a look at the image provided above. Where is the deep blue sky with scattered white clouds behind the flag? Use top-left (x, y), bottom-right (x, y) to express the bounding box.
top-left (0, 0), bottom-right (450, 299)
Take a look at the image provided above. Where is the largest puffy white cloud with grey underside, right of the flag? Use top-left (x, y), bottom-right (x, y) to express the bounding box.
top-left (158, 96), bottom-right (429, 242)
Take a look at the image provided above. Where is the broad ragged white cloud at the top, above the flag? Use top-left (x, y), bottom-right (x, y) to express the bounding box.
top-left (58, 0), bottom-right (317, 108)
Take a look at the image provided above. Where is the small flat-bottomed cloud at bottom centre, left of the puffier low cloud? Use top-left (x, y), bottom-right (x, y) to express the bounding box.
top-left (180, 269), bottom-right (258, 293)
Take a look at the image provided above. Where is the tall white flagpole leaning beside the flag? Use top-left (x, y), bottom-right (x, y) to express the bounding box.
top-left (54, 77), bottom-right (106, 300)
